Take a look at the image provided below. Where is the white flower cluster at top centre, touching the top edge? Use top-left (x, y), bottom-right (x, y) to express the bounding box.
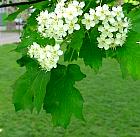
top-left (37, 0), bottom-right (85, 40)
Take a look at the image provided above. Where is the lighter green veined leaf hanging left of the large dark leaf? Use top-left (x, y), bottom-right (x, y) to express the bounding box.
top-left (13, 61), bottom-right (50, 113)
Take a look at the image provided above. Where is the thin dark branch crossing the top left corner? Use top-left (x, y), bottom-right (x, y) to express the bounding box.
top-left (0, 0), bottom-right (45, 8)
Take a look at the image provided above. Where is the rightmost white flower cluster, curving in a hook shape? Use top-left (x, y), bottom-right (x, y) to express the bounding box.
top-left (82, 4), bottom-right (130, 50)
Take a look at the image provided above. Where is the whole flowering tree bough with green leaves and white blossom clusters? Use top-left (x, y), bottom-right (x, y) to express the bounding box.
top-left (1, 0), bottom-right (140, 128)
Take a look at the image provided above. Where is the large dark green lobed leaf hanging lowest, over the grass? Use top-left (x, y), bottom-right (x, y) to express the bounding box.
top-left (44, 64), bottom-right (85, 128)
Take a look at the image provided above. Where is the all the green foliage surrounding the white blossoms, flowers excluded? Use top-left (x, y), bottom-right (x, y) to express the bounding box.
top-left (2, 0), bottom-right (140, 128)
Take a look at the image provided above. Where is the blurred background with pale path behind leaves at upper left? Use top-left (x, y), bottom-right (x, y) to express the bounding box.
top-left (0, 0), bottom-right (23, 45)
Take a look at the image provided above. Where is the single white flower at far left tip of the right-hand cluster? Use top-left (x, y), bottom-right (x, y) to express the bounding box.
top-left (82, 13), bottom-right (95, 30)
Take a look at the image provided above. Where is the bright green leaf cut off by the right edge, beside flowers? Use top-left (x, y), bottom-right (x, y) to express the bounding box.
top-left (116, 31), bottom-right (140, 79)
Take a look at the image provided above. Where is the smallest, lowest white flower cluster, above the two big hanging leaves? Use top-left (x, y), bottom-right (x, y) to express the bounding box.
top-left (28, 42), bottom-right (63, 71)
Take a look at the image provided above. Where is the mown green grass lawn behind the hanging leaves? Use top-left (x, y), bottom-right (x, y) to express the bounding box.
top-left (0, 45), bottom-right (140, 137)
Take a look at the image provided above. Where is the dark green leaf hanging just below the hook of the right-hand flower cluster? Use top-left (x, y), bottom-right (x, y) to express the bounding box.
top-left (80, 28), bottom-right (105, 71)
